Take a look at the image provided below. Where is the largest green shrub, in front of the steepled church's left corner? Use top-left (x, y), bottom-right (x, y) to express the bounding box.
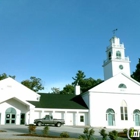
top-left (79, 127), bottom-right (95, 140)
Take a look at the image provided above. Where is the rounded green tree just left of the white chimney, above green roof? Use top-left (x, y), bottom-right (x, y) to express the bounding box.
top-left (60, 84), bottom-right (74, 94)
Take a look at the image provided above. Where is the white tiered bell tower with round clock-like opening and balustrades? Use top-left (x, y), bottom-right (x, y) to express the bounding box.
top-left (103, 36), bottom-right (130, 80)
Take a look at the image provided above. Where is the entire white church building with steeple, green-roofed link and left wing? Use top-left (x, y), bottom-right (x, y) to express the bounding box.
top-left (0, 36), bottom-right (140, 128)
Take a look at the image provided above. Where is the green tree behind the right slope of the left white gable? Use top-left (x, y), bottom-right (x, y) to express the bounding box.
top-left (21, 76), bottom-right (44, 92)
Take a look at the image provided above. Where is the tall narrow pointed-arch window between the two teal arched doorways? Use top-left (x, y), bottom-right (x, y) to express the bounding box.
top-left (120, 100), bottom-right (128, 120)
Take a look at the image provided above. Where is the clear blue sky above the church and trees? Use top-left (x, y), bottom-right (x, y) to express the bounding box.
top-left (0, 0), bottom-right (140, 92)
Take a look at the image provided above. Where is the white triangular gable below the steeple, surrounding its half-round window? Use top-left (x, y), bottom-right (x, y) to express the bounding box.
top-left (88, 73), bottom-right (140, 94)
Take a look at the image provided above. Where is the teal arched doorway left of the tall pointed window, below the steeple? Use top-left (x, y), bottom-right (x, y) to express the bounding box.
top-left (106, 108), bottom-right (115, 126)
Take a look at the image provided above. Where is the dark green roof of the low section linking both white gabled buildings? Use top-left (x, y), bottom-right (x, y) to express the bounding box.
top-left (28, 93), bottom-right (88, 109)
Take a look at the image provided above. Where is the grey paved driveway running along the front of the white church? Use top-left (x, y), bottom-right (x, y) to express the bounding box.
top-left (0, 125), bottom-right (124, 140)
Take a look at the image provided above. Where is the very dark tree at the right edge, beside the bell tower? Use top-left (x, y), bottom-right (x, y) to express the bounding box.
top-left (131, 58), bottom-right (140, 82)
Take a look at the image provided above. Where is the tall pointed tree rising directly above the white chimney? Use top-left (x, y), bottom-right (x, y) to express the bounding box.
top-left (72, 70), bottom-right (86, 86)
